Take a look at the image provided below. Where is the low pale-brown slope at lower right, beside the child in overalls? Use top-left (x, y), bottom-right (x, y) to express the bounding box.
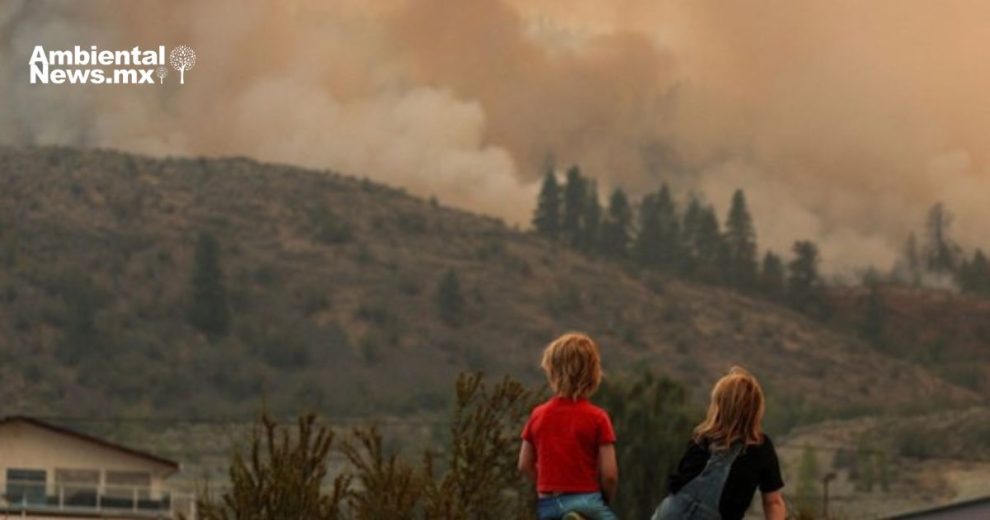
top-left (778, 407), bottom-right (990, 518)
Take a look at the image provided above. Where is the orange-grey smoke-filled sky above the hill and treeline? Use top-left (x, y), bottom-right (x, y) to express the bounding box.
top-left (0, 0), bottom-right (990, 271)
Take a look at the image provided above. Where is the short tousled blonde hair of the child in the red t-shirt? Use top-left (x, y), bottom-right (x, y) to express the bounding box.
top-left (540, 332), bottom-right (602, 399)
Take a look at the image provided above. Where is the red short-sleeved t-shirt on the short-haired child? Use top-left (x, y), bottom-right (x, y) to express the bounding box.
top-left (522, 397), bottom-right (615, 493)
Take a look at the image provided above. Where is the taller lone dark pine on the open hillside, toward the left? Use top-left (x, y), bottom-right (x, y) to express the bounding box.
top-left (188, 232), bottom-right (230, 337)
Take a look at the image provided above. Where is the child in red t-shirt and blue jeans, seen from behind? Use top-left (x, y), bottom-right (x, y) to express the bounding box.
top-left (519, 333), bottom-right (619, 520)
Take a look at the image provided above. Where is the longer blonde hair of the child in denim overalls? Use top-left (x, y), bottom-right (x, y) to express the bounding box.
top-left (694, 366), bottom-right (765, 449)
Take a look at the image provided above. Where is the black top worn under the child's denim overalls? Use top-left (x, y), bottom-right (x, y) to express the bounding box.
top-left (668, 435), bottom-right (784, 520)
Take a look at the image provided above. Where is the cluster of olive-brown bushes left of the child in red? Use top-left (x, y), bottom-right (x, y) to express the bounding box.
top-left (198, 374), bottom-right (536, 520)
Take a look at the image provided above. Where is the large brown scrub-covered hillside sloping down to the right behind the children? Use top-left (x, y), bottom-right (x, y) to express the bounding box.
top-left (0, 148), bottom-right (980, 428)
